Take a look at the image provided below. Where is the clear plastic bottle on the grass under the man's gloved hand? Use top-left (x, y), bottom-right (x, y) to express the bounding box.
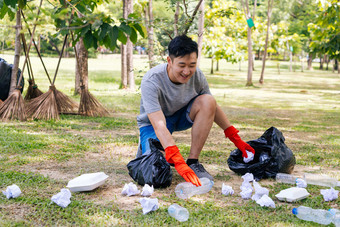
top-left (175, 177), bottom-right (214, 199)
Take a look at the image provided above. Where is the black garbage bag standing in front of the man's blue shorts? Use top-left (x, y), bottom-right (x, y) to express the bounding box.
top-left (127, 139), bottom-right (172, 188)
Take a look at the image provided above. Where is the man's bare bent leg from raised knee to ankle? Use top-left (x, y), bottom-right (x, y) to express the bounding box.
top-left (188, 94), bottom-right (217, 159)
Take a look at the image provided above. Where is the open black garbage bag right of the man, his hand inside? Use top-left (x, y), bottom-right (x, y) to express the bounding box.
top-left (228, 127), bottom-right (296, 180)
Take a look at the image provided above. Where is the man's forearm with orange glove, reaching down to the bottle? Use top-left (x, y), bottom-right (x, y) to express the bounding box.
top-left (148, 110), bottom-right (201, 186)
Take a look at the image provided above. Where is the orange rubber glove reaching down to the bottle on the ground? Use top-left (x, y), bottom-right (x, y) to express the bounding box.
top-left (165, 145), bottom-right (201, 186)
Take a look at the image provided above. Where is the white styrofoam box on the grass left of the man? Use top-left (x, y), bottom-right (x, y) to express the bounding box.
top-left (66, 172), bottom-right (109, 192)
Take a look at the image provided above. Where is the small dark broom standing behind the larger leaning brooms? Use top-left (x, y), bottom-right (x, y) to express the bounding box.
top-left (21, 34), bottom-right (43, 100)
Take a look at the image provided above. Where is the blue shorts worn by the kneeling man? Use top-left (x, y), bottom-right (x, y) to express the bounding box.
top-left (137, 97), bottom-right (196, 156)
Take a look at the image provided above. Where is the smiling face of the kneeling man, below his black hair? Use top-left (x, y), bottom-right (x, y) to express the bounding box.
top-left (167, 52), bottom-right (197, 84)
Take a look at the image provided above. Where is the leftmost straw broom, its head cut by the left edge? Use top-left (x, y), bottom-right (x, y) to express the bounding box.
top-left (0, 0), bottom-right (43, 121)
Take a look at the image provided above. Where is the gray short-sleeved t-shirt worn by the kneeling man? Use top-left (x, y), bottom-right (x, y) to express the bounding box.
top-left (137, 63), bottom-right (211, 128)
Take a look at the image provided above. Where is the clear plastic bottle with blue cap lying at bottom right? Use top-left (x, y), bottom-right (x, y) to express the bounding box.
top-left (292, 206), bottom-right (333, 225)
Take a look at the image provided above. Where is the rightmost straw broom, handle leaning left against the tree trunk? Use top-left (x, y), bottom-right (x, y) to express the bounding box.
top-left (71, 33), bottom-right (109, 117)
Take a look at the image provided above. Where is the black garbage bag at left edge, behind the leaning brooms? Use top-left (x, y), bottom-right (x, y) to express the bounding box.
top-left (0, 58), bottom-right (24, 101)
